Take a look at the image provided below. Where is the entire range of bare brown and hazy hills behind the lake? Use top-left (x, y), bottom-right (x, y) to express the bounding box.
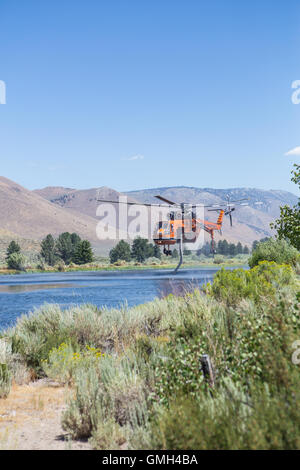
top-left (0, 177), bottom-right (298, 254)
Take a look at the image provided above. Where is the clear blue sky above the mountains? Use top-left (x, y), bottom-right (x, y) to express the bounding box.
top-left (0, 0), bottom-right (300, 193)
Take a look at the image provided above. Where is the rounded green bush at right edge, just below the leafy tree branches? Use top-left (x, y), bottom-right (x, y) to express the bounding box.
top-left (248, 238), bottom-right (300, 268)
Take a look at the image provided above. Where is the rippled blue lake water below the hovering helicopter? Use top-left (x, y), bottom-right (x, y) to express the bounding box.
top-left (0, 268), bottom-right (241, 330)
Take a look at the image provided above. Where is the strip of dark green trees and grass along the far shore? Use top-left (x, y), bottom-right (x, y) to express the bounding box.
top-left (0, 234), bottom-right (253, 274)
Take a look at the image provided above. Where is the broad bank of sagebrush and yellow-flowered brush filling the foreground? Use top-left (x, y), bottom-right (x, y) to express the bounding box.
top-left (0, 262), bottom-right (300, 449)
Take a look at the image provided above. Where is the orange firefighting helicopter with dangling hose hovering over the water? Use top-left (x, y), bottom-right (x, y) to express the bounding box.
top-left (97, 195), bottom-right (251, 274)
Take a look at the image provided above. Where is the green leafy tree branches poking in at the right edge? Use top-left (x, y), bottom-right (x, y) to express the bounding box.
top-left (271, 164), bottom-right (300, 251)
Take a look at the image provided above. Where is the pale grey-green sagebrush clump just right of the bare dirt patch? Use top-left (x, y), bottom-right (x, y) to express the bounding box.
top-left (62, 357), bottom-right (146, 438)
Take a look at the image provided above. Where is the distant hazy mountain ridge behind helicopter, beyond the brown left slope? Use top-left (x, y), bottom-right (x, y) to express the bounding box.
top-left (34, 186), bottom-right (298, 245)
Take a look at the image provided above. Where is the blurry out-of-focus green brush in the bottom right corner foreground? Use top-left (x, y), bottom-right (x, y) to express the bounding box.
top-left (151, 381), bottom-right (300, 450)
